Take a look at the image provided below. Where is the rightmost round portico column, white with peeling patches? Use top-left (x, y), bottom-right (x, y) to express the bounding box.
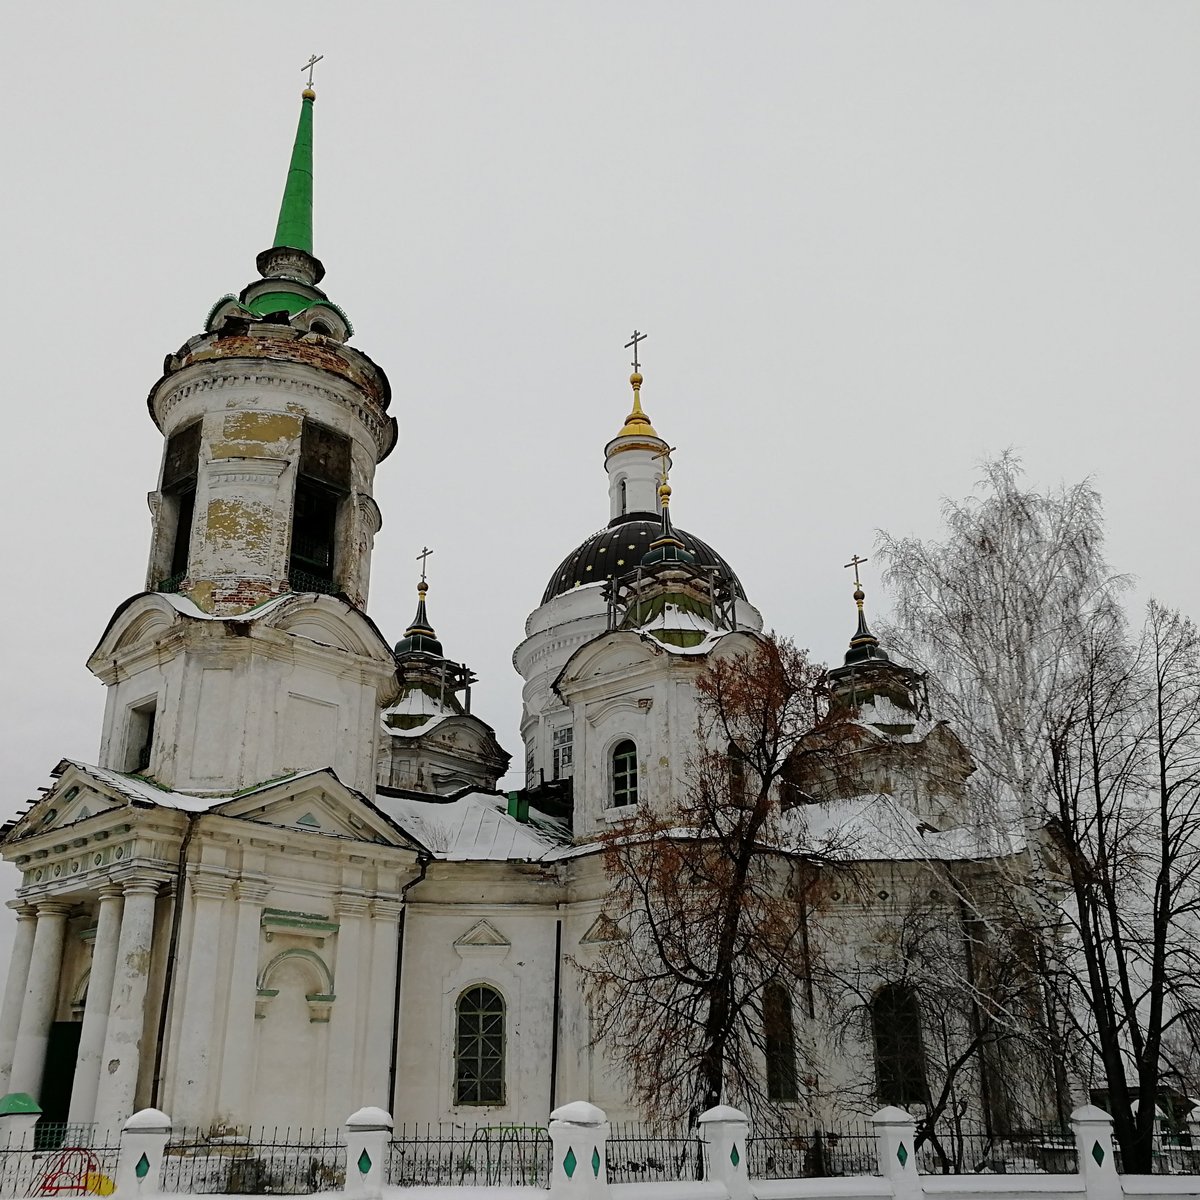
top-left (95, 878), bottom-right (158, 1129)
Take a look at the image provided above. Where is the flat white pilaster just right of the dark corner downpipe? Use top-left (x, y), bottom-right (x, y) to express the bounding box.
top-left (167, 870), bottom-right (232, 1126)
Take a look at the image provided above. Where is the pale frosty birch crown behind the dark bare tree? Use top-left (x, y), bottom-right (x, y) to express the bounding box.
top-left (880, 452), bottom-right (1127, 823)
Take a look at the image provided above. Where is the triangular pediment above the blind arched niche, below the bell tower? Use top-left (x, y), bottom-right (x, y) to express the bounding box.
top-left (212, 770), bottom-right (410, 847)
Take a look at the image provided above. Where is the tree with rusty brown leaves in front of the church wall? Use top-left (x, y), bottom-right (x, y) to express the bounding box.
top-left (578, 636), bottom-right (852, 1120)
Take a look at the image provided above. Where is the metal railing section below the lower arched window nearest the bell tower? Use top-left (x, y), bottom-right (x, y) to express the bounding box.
top-left (386, 1124), bottom-right (551, 1188)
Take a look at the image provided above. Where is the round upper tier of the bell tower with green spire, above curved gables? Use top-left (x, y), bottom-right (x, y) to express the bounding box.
top-left (146, 79), bottom-right (396, 616)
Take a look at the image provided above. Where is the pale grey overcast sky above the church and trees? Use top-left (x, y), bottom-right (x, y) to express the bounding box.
top-left (0, 0), bottom-right (1200, 960)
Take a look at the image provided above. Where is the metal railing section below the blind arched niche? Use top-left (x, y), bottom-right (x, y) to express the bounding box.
top-left (161, 1128), bottom-right (346, 1195)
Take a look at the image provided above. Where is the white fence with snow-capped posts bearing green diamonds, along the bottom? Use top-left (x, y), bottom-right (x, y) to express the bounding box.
top-left (0, 1100), bottom-right (1200, 1200)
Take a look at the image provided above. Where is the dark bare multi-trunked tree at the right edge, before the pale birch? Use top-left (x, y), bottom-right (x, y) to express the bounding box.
top-left (1048, 602), bottom-right (1200, 1171)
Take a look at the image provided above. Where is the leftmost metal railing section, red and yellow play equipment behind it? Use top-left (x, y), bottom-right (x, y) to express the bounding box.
top-left (0, 1122), bottom-right (120, 1196)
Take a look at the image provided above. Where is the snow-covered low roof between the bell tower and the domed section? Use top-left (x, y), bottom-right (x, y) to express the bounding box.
top-left (376, 792), bottom-right (570, 863)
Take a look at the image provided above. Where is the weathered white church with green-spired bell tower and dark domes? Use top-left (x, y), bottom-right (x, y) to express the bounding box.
top-left (0, 85), bottom-right (1032, 1129)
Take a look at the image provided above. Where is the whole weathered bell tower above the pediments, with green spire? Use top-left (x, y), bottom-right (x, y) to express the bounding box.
top-left (88, 84), bottom-right (397, 794)
